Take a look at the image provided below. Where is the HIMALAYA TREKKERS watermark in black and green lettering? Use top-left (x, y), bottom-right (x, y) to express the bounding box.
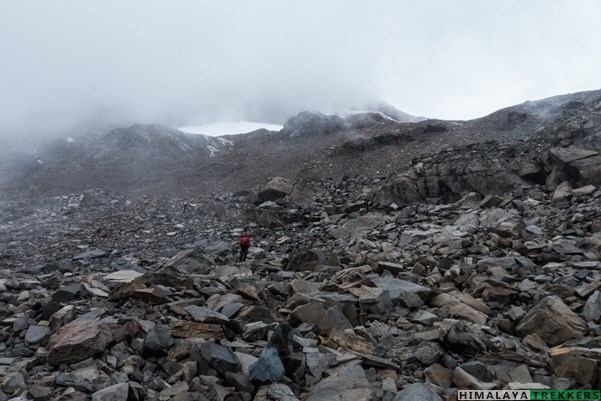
top-left (457, 390), bottom-right (601, 401)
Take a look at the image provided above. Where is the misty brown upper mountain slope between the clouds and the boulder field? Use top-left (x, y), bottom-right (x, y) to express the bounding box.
top-left (0, 91), bottom-right (601, 195)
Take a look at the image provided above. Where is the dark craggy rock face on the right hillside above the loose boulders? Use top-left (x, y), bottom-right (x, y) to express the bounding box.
top-left (373, 92), bottom-right (601, 205)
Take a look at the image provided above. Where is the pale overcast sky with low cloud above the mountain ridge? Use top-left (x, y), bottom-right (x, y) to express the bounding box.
top-left (0, 0), bottom-right (601, 136)
